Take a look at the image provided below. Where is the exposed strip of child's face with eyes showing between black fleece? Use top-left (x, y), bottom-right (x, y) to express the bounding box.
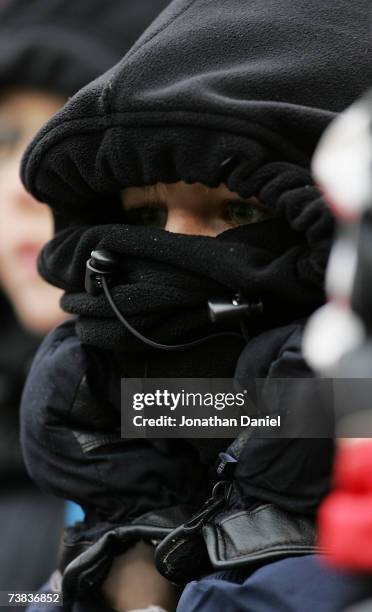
top-left (122, 181), bottom-right (271, 236)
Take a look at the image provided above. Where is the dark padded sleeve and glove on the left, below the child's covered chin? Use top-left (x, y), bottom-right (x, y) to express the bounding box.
top-left (21, 321), bottom-right (208, 591)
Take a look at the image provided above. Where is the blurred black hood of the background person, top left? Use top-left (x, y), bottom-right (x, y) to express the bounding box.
top-left (0, 0), bottom-right (169, 96)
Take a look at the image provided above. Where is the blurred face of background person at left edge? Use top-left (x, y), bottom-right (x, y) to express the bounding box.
top-left (0, 90), bottom-right (64, 335)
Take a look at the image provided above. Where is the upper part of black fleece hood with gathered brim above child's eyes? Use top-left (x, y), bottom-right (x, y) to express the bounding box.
top-left (22, 0), bottom-right (371, 216)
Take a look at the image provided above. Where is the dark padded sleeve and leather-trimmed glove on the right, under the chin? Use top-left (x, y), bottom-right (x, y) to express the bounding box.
top-left (156, 323), bottom-right (333, 584)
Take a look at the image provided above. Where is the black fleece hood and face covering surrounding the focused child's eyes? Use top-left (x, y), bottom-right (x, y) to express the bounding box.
top-left (19, 0), bottom-right (370, 348)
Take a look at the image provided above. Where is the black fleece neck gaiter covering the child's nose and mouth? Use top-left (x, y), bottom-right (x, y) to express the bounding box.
top-left (40, 220), bottom-right (310, 350)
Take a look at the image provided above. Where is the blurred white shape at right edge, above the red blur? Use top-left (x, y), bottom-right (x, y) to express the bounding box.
top-left (303, 90), bottom-right (372, 376)
